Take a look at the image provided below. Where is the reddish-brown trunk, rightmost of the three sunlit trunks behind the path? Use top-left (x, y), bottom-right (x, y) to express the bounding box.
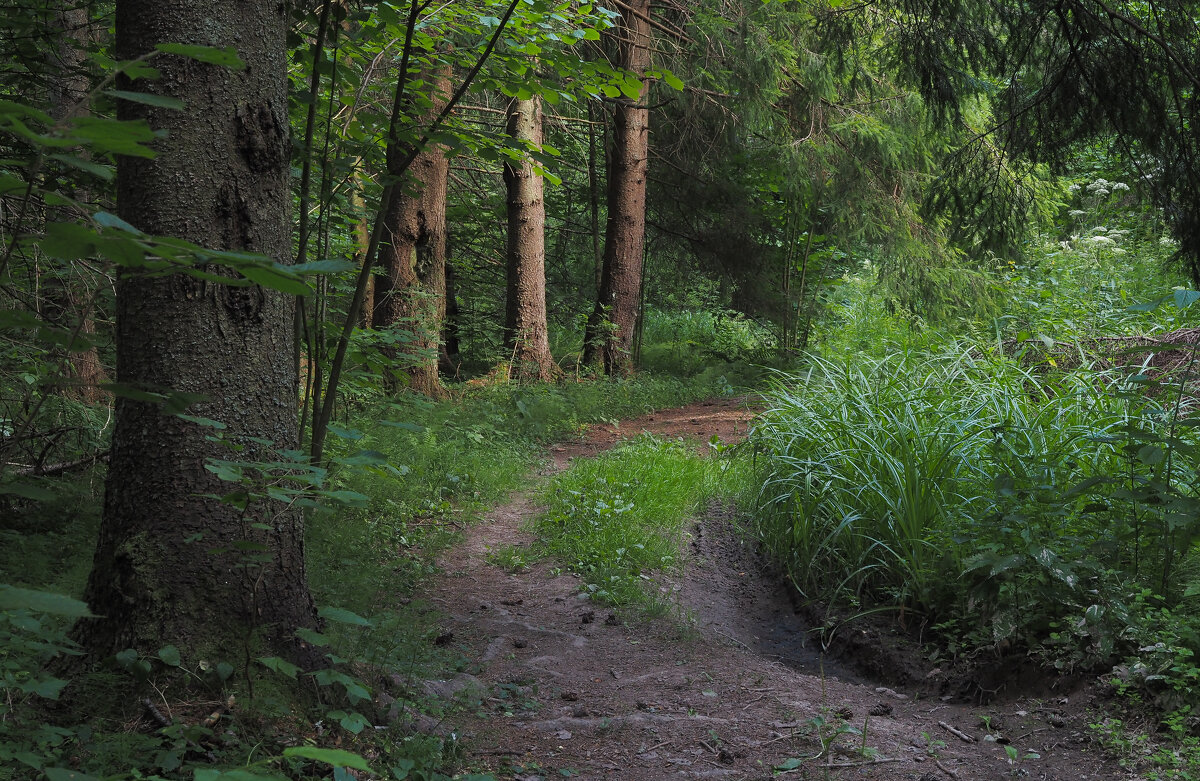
top-left (583, 0), bottom-right (650, 374)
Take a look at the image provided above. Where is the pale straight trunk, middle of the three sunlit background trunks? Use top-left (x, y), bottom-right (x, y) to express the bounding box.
top-left (504, 96), bottom-right (559, 382)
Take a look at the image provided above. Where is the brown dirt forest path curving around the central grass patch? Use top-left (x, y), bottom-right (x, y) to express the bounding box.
top-left (410, 399), bottom-right (1113, 781)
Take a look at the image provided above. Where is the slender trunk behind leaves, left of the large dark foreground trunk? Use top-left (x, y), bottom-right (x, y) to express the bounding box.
top-left (43, 0), bottom-right (109, 404)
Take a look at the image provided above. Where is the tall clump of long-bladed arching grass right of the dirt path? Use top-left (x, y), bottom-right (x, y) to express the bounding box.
top-left (751, 346), bottom-right (1200, 656)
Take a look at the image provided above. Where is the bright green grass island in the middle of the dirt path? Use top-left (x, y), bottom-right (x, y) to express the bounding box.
top-left (535, 434), bottom-right (738, 614)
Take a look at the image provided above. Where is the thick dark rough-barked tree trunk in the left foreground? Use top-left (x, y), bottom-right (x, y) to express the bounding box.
top-left (79, 0), bottom-right (317, 662)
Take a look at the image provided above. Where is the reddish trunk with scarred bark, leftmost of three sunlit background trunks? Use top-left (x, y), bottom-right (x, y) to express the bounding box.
top-left (373, 66), bottom-right (450, 396)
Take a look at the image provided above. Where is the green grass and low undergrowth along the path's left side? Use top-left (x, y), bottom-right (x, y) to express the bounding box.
top-left (0, 373), bottom-right (758, 779)
